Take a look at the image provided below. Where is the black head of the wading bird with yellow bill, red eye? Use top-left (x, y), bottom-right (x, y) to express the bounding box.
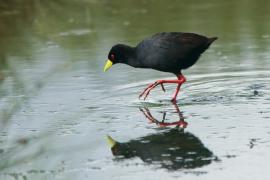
top-left (104, 44), bottom-right (134, 72)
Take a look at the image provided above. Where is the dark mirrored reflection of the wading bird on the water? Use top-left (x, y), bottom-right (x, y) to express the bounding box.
top-left (108, 102), bottom-right (217, 170)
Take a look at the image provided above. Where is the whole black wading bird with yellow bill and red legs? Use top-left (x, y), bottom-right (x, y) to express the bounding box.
top-left (104, 32), bottom-right (217, 102)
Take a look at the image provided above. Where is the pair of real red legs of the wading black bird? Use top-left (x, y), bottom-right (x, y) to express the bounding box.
top-left (139, 74), bottom-right (186, 102)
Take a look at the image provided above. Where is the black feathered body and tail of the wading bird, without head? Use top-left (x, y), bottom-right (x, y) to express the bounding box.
top-left (136, 32), bottom-right (217, 74)
